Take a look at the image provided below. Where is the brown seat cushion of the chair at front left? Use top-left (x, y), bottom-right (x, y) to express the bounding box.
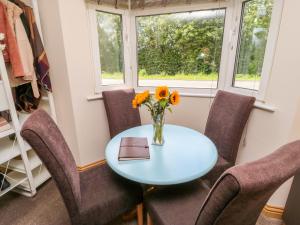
top-left (80, 164), bottom-right (142, 224)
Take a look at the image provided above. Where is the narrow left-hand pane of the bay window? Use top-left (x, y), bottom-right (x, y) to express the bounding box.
top-left (97, 11), bottom-right (124, 85)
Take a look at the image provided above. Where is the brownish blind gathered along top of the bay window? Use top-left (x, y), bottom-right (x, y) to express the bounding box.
top-left (88, 0), bottom-right (220, 9)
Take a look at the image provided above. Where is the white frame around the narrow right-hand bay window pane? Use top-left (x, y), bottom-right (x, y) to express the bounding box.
top-left (224, 0), bottom-right (284, 101)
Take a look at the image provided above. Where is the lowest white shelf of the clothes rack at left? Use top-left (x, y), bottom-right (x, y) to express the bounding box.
top-left (18, 166), bottom-right (51, 191)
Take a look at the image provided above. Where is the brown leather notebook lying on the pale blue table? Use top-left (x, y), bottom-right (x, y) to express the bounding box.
top-left (118, 137), bottom-right (150, 161)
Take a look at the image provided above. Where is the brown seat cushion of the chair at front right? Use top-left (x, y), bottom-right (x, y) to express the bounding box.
top-left (145, 180), bottom-right (209, 225)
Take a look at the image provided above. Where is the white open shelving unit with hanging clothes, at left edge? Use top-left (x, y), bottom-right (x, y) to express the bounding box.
top-left (0, 0), bottom-right (56, 197)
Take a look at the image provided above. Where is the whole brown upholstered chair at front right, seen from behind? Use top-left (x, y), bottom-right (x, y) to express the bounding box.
top-left (145, 141), bottom-right (300, 225)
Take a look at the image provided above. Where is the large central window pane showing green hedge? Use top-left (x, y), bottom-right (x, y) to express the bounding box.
top-left (136, 9), bottom-right (225, 88)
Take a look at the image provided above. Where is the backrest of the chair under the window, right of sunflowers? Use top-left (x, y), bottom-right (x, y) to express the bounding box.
top-left (205, 91), bottom-right (255, 164)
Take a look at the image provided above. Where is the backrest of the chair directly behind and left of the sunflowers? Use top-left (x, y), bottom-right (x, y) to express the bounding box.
top-left (102, 89), bottom-right (141, 138)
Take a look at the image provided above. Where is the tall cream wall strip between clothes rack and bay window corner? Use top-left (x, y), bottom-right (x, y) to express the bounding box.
top-left (38, 0), bottom-right (80, 161)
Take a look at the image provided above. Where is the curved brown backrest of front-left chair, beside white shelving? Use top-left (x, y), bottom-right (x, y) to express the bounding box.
top-left (21, 110), bottom-right (81, 221)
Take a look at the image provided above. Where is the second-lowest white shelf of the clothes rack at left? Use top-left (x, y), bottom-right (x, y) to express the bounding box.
top-left (2, 150), bottom-right (42, 173)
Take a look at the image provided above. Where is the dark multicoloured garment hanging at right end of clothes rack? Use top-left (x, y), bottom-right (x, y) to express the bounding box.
top-left (11, 0), bottom-right (52, 91)
